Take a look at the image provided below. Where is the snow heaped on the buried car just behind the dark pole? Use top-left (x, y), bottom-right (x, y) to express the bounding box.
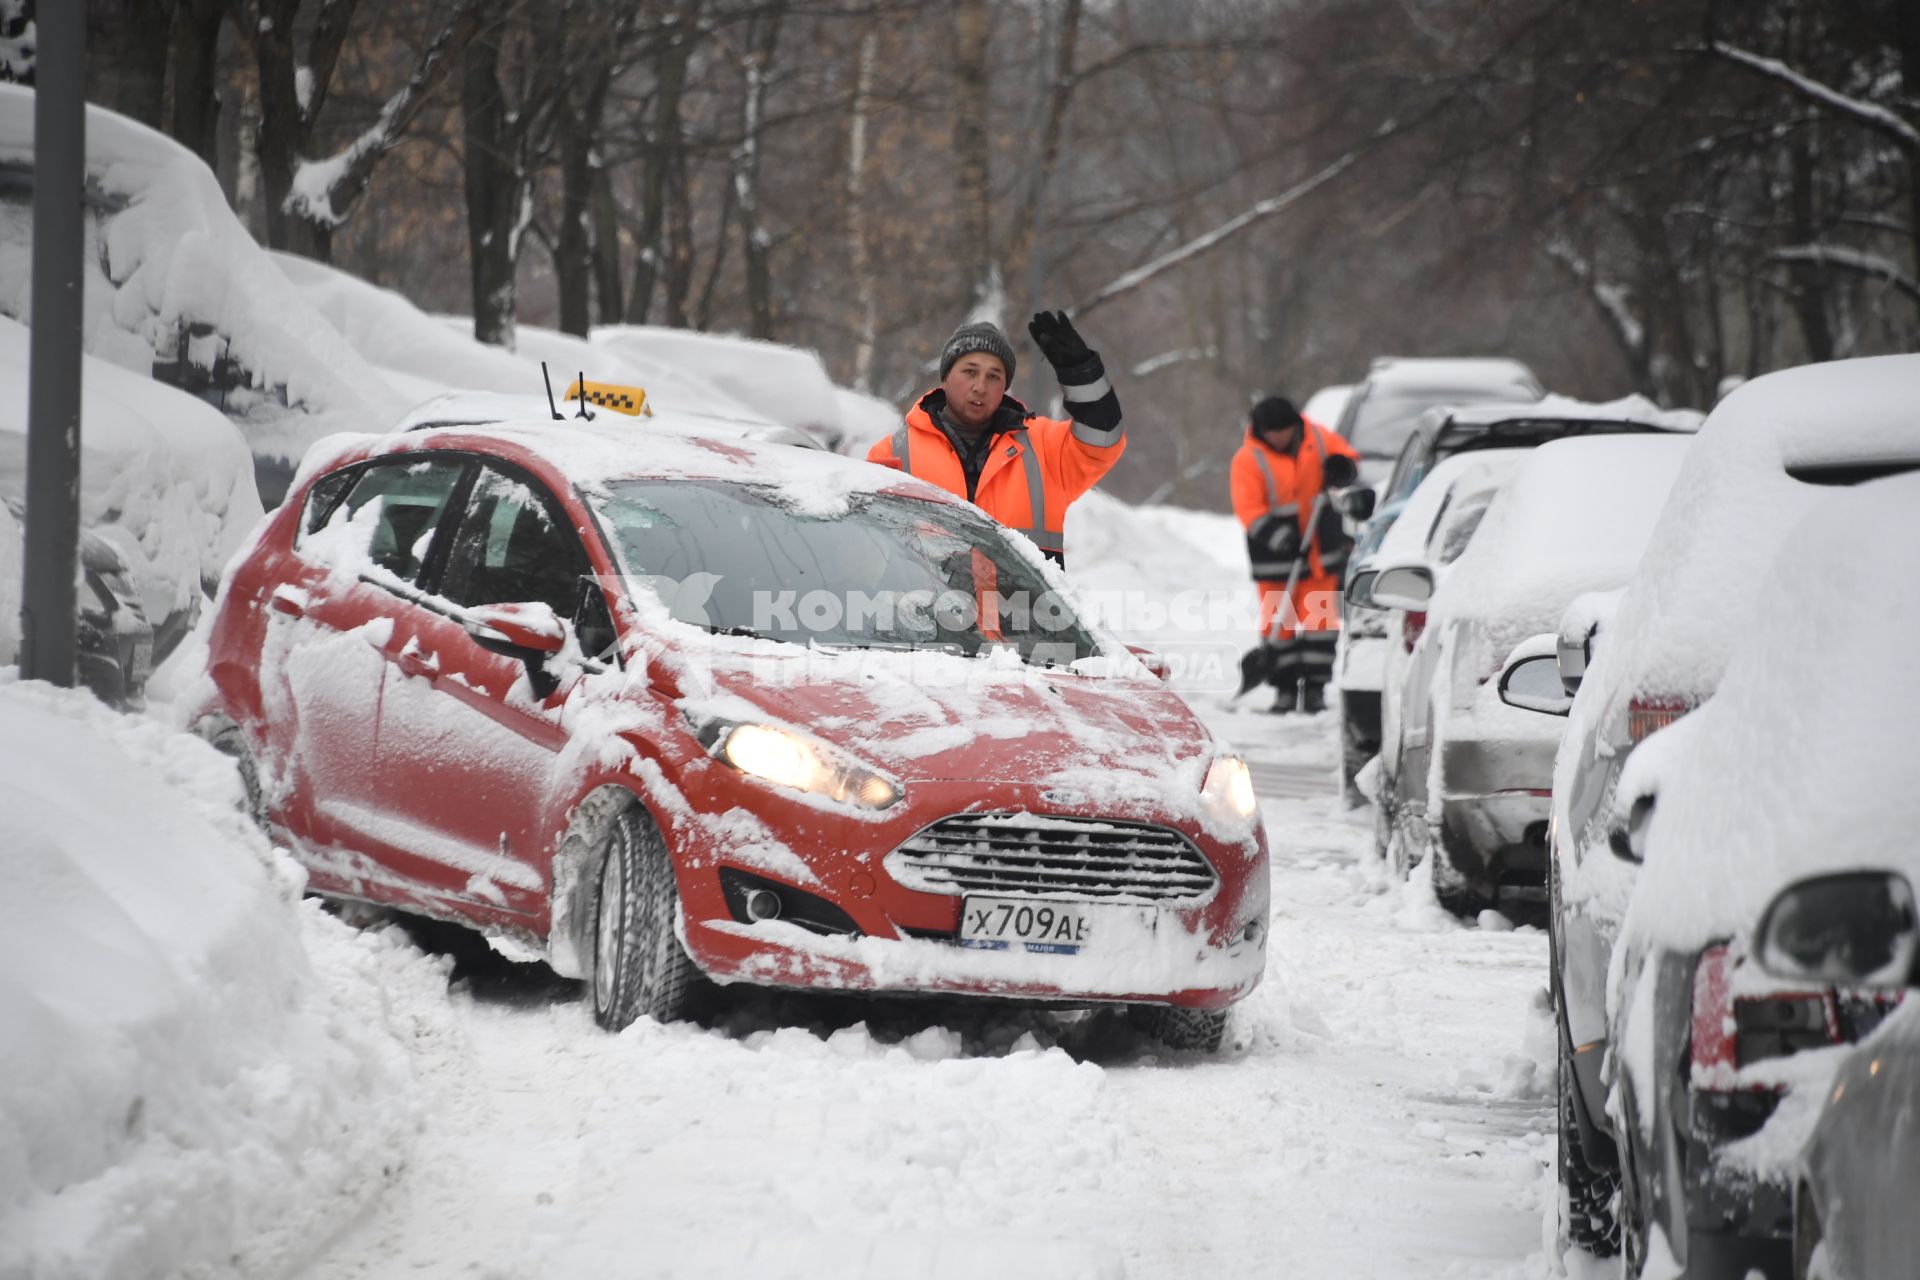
top-left (0, 317), bottom-right (261, 660)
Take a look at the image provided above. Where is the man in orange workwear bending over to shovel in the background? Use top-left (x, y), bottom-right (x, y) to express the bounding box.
top-left (1229, 395), bottom-right (1359, 712)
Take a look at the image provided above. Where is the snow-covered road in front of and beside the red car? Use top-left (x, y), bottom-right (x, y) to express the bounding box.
top-left (295, 498), bottom-right (1553, 1280)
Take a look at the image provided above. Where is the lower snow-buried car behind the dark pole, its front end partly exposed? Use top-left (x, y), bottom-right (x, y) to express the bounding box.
top-left (0, 317), bottom-right (261, 706)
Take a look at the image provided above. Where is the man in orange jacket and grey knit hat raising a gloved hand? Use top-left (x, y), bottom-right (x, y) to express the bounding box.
top-left (866, 311), bottom-right (1127, 564)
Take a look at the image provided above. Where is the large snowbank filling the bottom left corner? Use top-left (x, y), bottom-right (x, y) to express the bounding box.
top-left (0, 683), bottom-right (444, 1280)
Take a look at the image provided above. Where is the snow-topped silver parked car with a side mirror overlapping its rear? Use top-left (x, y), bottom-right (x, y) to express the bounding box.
top-left (1371, 436), bottom-right (1692, 915)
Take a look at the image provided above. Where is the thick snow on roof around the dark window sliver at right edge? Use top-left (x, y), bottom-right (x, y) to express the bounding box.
top-left (1574, 355), bottom-right (1920, 716)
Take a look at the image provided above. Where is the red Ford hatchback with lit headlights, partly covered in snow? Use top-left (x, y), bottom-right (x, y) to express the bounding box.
top-left (198, 415), bottom-right (1267, 1050)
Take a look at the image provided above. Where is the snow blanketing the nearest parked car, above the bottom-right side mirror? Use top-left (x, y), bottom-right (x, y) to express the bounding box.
top-left (1622, 476), bottom-right (1920, 959)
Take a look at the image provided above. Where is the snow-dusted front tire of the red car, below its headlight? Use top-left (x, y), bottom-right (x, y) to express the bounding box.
top-left (589, 810), bottom-right (701, 1031)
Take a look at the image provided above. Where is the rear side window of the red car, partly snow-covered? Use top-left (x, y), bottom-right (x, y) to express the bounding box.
top-left (301, 457), bottom-right (467, 583)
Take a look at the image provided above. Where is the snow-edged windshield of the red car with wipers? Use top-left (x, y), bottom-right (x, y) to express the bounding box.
top-left (593, 480), bottom-right (1098, 666)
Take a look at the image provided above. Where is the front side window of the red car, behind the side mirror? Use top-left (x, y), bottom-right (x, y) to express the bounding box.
top-left (440, 466), bottom-right (588, 618)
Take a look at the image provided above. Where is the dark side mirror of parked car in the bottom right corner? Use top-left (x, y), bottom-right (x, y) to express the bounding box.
top-left (1753, 871), bottom-right (1920, 986)
